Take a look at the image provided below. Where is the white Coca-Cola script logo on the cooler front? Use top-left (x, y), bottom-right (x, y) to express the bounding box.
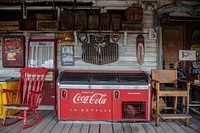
top-left (73, 93), bottom-right (107, 104)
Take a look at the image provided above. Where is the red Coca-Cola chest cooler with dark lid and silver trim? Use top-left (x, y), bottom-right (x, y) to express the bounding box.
top-left (56, 70), bottom-right (152, 121)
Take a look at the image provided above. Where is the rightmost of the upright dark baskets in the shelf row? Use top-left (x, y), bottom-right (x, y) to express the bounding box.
top-left (111, 14), bottom-right (122, 30)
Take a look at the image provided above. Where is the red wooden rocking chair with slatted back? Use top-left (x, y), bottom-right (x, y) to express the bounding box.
top-left (2, 68), bottom-right (48, 129)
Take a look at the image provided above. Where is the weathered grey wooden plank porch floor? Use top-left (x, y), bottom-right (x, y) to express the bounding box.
top-left (0, 110), bottom-right (200, 133)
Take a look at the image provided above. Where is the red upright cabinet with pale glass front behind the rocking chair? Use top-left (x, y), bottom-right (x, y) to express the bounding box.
top-left (27, 39), bottom-right (57, 105)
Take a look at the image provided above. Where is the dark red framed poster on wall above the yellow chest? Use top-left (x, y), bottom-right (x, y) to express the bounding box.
top-left (2, 36), bottom-right (25, 67)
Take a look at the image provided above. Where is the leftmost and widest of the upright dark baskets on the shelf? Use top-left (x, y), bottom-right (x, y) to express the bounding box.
top-left (60, 10), bottom-right (75, 30)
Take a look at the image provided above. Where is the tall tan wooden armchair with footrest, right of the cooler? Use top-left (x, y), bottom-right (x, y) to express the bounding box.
top-left (151, 70), bottom-right (191, 126)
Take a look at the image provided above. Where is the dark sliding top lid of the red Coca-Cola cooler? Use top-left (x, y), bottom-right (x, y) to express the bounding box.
top-left (59, 72), bottom-right (148, 85)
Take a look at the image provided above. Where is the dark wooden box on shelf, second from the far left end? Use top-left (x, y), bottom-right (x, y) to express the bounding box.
top-left (20, 19), bottom-right (36, 30)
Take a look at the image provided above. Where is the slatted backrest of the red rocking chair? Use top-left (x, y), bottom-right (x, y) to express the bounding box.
top-left (18, 68), bottom-right (48, 105)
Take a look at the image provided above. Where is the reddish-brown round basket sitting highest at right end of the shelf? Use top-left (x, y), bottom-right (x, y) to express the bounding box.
top-left (125, 7), bottom-right (143, 21)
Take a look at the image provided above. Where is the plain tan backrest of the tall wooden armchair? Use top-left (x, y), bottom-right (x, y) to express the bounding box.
top-left (151, 69), bottom-right (177, 83)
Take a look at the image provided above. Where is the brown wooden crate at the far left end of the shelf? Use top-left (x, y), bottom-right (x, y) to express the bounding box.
top-left (0, 21), bottom-right (19, 31)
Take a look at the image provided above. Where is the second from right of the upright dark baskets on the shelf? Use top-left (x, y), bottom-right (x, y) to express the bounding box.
top-left (99, 13), bottom-right (110, 30)
